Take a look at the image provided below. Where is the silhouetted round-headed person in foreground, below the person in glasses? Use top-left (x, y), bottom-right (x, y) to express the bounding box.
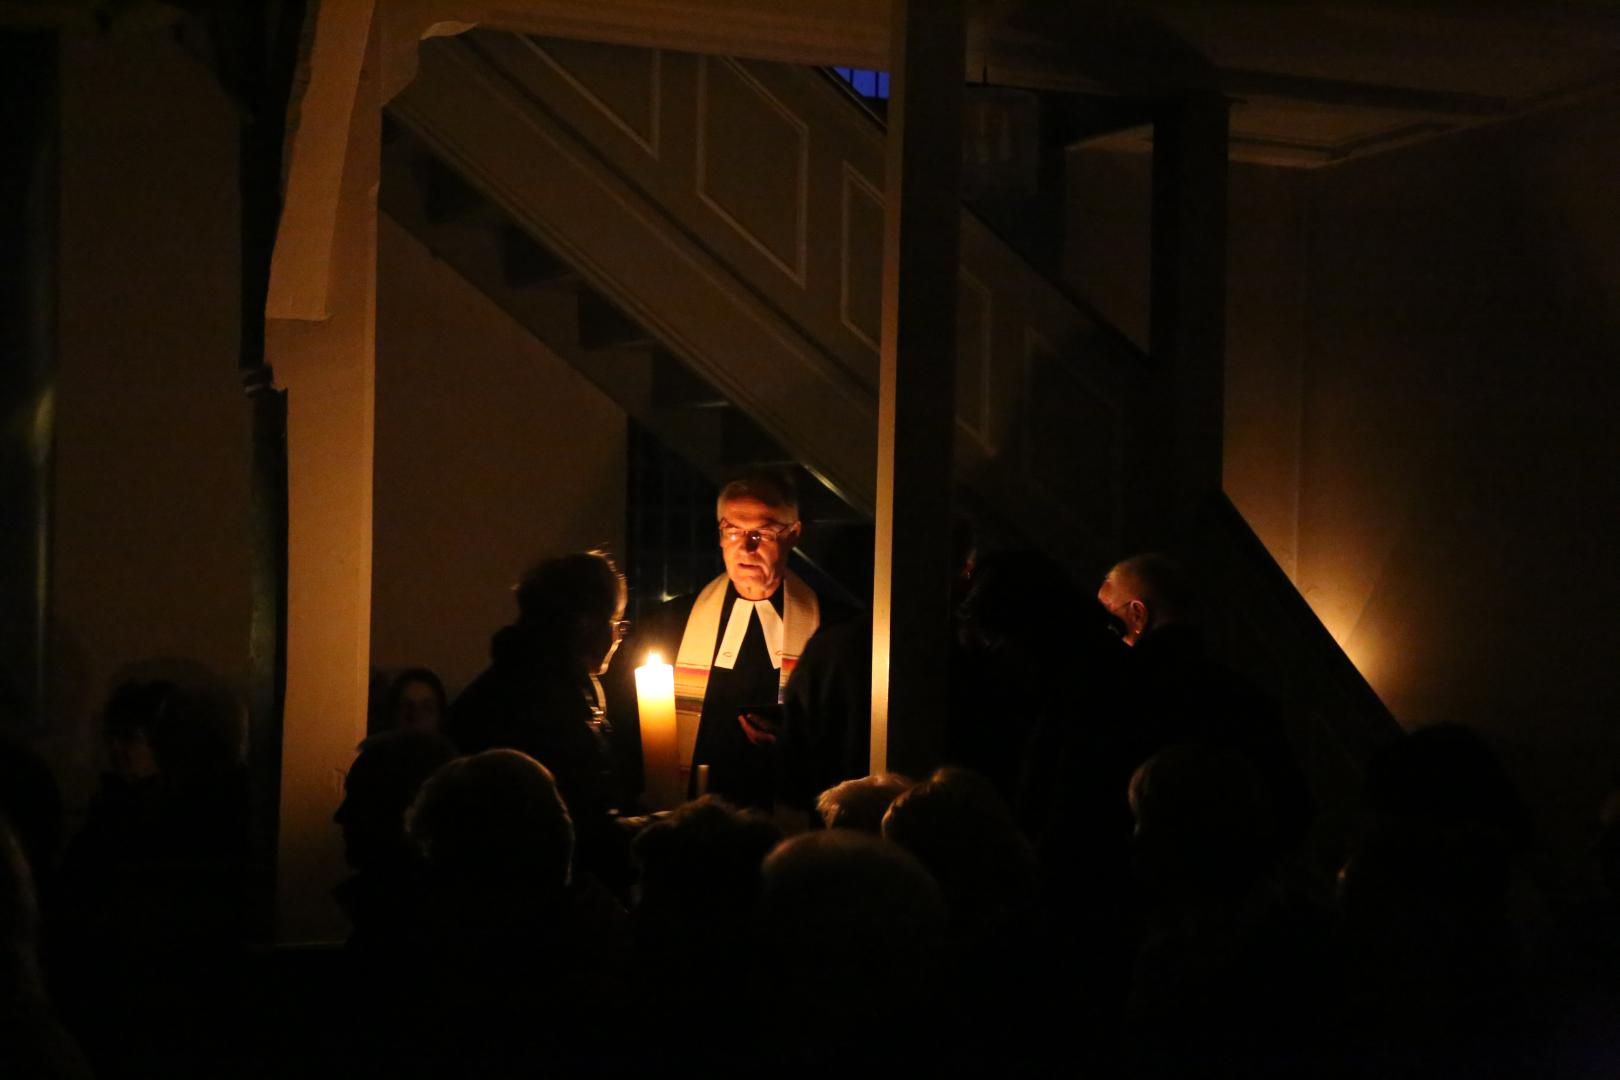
top-left (400, 750), bottom-right (625, 1075)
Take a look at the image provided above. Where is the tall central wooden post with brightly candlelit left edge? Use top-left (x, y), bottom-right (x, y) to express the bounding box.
top-left (872, 0), bottom-right (966, 774)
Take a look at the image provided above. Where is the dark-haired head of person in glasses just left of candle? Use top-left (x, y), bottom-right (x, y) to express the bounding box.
top-left (517, 551), bottom-right (629, 675)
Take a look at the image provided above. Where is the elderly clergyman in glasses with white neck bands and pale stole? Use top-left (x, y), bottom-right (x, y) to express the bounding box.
top-left (609, 473), bottom-right (842, 806)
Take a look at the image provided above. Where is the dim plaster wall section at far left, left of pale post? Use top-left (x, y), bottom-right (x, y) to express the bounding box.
top-left (45, 31), bottom-right (249, 803)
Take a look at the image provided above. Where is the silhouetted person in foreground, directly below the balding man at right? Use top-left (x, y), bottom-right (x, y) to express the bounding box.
top-left (1126, 743), bottom-right (1340, 1077)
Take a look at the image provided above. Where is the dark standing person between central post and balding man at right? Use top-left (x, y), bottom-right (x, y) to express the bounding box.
top-left (946, 551), bottom-right (1131, 1065)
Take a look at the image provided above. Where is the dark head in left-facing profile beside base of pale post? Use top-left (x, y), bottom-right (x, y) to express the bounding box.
top-left (332, 729), bottom-right (455, 870)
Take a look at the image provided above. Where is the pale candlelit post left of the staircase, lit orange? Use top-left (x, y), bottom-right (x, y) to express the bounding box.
top-left (266, 19), bottom-right (382, 942)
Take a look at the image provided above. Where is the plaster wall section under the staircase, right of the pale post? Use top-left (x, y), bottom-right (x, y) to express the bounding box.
top-left (371, 215), bottom-right (627, 695)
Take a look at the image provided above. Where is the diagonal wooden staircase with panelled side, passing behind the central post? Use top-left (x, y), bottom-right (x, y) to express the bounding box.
top-left (382, 31), bottom-right (1147, 579)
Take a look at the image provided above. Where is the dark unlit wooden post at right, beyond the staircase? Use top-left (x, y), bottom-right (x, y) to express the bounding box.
top-left (1150, 89), bottom-right (1226, 525)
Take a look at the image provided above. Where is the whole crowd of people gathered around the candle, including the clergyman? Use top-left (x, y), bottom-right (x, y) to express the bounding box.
top-left (0, 474), bottom-right (1620, 1078)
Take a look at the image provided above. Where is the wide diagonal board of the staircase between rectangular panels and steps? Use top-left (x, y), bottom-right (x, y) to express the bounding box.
top-left (390, 36), bottom-right (876, 507)
